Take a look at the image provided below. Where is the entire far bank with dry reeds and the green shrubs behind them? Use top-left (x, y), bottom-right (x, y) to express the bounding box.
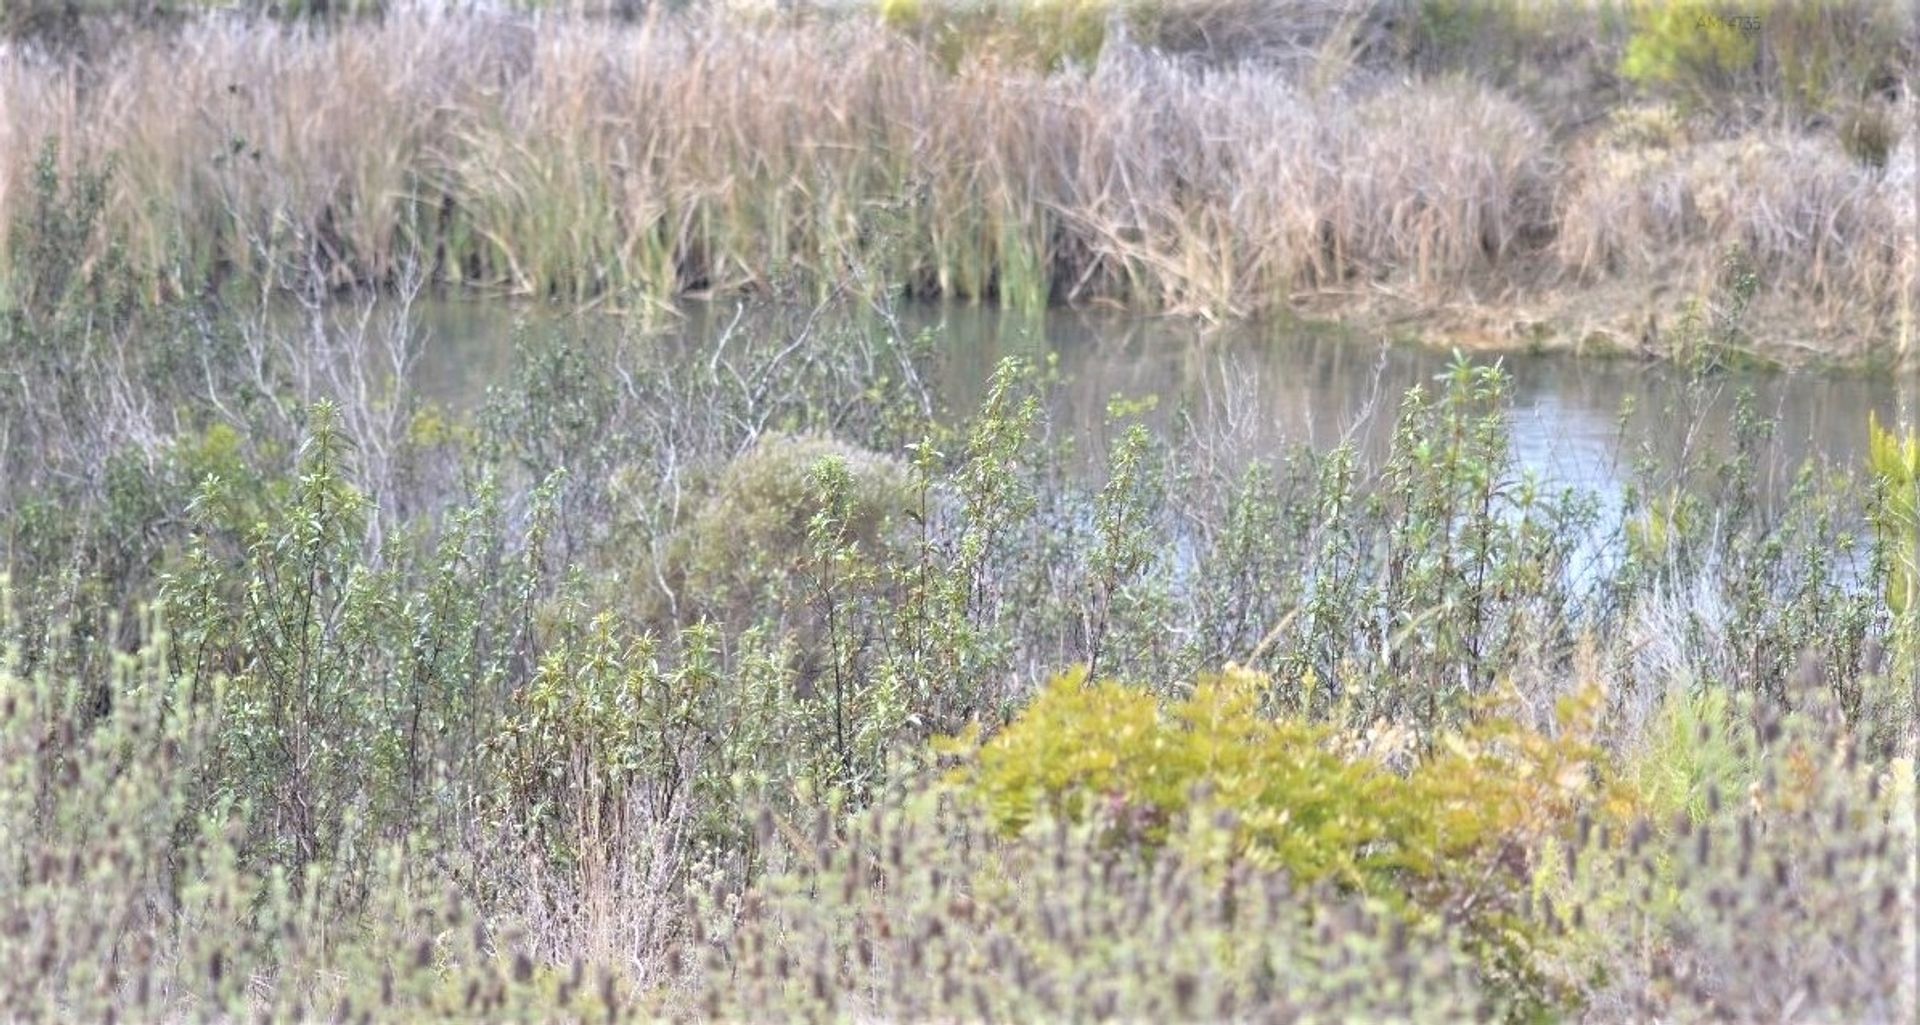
top-left (0, 2), bottom-right (1916, 359)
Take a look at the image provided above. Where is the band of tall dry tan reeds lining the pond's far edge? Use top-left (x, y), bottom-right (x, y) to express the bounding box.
top-left (0, 6), bottom-right (1914, 349)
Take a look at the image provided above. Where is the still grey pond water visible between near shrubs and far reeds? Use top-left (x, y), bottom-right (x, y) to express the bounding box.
top-left (415, 301), bottom-right (1914, 497)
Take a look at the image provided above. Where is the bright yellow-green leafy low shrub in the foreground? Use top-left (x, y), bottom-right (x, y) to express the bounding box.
top-left (944, 670), bottom-right (1624, 1006)
